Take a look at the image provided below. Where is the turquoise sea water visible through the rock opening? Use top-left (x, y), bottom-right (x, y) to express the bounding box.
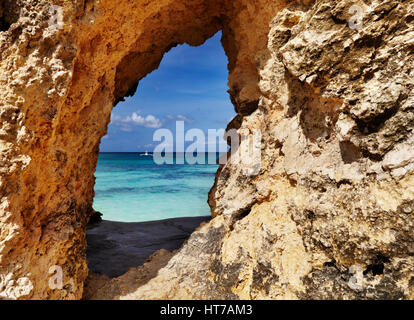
top-left (93, 153), bottom-right (218, 222)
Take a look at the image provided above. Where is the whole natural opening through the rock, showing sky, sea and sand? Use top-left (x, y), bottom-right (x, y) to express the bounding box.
top-left (87, 32), bottom-right (235, 277)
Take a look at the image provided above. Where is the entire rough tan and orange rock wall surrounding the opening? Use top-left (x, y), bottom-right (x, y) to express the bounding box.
top-left (0, 0), bottom-right (414, 299)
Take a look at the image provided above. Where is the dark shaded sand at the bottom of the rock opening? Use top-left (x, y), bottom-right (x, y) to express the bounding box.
top-left (86, 216), bottom-right (211, 278)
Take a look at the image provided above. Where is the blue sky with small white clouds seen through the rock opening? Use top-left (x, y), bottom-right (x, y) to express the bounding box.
top-left (100, 32), bottom-right (236, 152)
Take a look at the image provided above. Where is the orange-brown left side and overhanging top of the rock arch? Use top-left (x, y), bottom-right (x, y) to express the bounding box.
top-left (0, 0), bottom-right (282, 299)
